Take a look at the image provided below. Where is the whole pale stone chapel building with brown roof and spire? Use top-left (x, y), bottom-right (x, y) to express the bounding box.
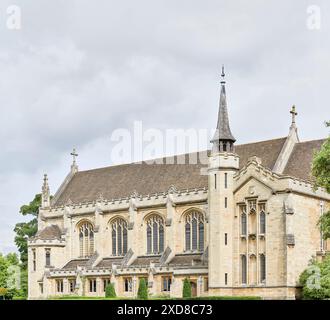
top-left (28, 68), bottom-right (330, 299)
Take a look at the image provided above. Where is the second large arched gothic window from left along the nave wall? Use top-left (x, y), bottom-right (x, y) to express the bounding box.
top-left (110, 218), bottom-right (127, 256)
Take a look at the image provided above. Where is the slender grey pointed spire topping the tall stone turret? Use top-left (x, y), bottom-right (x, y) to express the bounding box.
top-left (211, 66), bottom-right (236, 152)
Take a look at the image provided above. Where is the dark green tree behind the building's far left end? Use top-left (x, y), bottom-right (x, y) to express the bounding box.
top-left (14, 194), bottom-right (41, 269)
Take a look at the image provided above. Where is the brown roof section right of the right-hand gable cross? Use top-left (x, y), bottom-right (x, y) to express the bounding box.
top-left (283, 139), bottom-right (326, 181)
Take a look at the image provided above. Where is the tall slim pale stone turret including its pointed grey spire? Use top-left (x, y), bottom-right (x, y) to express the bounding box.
top-left (208, 68), bottom-right (239, 295)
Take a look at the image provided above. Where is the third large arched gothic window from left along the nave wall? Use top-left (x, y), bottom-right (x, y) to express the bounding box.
top-left (146, 214), bottom-right (164, 254)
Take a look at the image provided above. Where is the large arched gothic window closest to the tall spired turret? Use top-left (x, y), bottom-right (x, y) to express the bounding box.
top-left (185, 211), bottom-right (204, 251)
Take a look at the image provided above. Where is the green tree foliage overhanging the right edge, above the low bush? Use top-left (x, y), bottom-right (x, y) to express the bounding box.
top-left (312, 122), bottom-right (330, 240)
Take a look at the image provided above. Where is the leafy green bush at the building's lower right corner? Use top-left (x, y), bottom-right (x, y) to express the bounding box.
top-left (299, 255), bottom-right (330, 300)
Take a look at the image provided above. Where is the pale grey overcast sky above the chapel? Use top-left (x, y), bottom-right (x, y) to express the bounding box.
top-left (0, 0), bottom-right (330, 252)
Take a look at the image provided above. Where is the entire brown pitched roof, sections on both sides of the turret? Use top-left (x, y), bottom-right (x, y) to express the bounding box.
top-left (53, 138), bottom-right (324, 206)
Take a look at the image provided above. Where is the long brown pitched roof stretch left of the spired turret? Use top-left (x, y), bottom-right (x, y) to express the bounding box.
top-left (53, 156), bottom-right (207, 206)
